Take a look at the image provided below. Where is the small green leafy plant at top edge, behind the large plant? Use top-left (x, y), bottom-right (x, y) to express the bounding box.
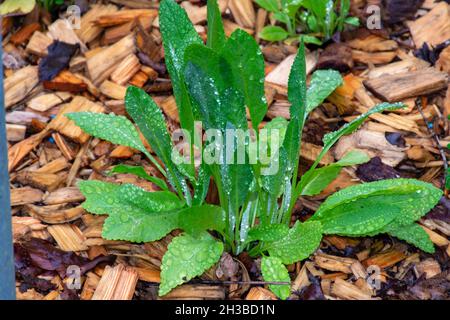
top-left (255, 0), bottom-right (359, 45)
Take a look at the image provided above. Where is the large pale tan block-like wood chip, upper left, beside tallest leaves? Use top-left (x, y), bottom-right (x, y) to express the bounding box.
top-left (86, 34), bottom-right (136, 85)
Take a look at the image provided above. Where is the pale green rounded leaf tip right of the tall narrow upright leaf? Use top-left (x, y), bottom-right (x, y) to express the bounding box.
top-left (306, 70), bottom-right (343, 114)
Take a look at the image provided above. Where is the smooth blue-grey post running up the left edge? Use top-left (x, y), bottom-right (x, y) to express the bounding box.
top-left (0, 17), bottom-right (16, 300)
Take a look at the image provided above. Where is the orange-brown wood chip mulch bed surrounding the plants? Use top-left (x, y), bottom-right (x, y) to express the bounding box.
top-left (2, 0), bottom-right (450, 300)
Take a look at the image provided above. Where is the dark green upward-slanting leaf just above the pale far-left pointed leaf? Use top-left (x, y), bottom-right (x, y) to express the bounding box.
top-left (125, 86), bottom-right (190, 199)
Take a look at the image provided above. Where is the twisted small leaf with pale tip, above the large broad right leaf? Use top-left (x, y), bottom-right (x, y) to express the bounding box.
top-left (299, 150), bottom-right (370, 196)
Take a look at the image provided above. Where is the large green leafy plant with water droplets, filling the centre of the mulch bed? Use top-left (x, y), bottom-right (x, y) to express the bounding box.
top-left (66, 0), bottom-right (442, 299)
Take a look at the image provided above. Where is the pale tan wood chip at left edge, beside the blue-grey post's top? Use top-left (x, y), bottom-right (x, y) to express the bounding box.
top-left (4, 65), bottom-right (39, 109)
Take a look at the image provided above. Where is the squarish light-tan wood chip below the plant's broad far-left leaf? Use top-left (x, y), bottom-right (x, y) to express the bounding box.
top-left (47, 224), bottom-right (88, 251)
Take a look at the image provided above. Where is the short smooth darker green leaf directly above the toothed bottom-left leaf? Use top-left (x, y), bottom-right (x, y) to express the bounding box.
top-left (179, 204), bottom-right (225, 236)
